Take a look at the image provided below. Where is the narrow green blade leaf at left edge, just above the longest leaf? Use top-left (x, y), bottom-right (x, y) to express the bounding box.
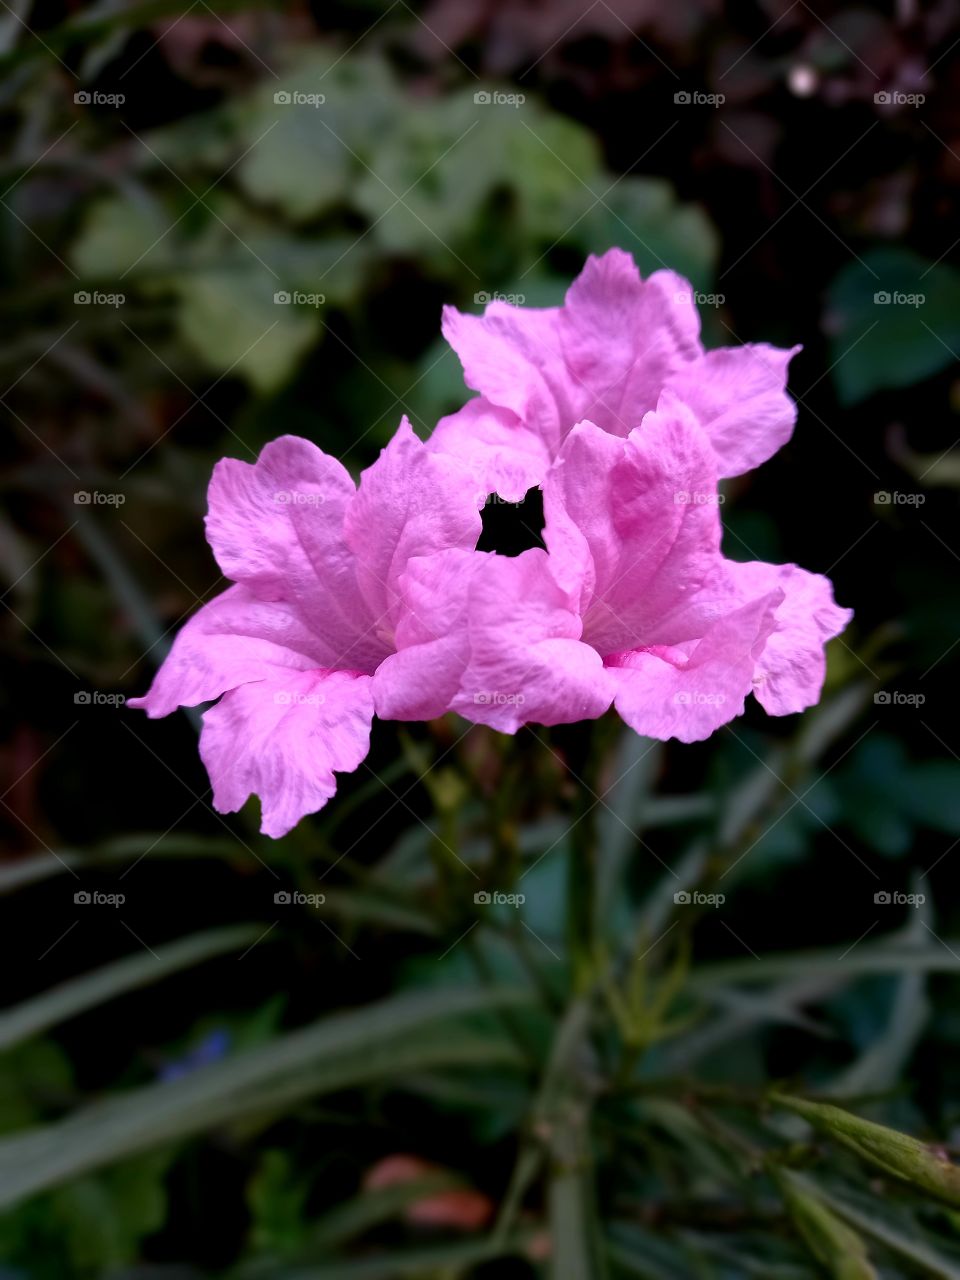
top-left (0, 924), bottom-right (264, 1050)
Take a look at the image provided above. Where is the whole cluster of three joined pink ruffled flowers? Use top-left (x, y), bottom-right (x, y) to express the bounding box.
top-left (131, 250), bottom-right (850, 836)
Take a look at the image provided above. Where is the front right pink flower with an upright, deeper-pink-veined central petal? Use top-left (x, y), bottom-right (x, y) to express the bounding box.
top-left (417, 392), bottom-right (850, 742)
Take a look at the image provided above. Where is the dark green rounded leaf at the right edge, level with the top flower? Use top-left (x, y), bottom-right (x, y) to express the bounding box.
top-left (823, 247), bottom-right (960, 404)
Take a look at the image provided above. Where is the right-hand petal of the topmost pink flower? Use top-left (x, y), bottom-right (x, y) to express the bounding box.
top-left (667, 343), bottom-right (800, 476)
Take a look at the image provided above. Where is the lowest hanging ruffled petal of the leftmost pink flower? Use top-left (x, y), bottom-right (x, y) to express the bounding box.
top-left (200, 671), bottom-right (374, 837)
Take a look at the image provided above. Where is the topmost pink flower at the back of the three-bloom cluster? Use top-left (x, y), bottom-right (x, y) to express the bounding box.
top-left (430, 248), bottom-right (800, 500)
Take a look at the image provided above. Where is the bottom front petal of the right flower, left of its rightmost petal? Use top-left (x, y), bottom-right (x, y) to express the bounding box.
top-left (607, 590), bottom-right (783, 742)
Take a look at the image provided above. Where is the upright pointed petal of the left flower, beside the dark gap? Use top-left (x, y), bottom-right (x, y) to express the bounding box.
top-left (344, 417), bottom-right (483, 632)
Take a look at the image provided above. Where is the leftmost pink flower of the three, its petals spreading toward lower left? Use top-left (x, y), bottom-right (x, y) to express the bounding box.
top-left (131, 420), bottom-right (480, 836)
